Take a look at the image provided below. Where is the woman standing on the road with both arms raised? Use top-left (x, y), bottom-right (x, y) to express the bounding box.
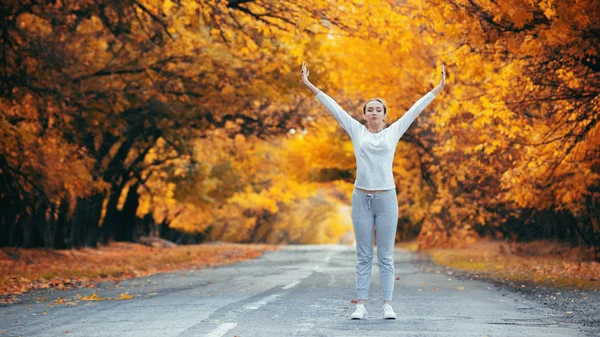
top-left (302, 63), bottom-right (446, 319)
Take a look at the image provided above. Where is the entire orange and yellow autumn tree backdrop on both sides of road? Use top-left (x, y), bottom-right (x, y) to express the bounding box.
top-left (0, 0), bottom-right (600, 258)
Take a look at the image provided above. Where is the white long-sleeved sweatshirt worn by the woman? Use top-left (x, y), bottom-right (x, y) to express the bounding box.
top-left (316, 91), bottom-right (435, 191)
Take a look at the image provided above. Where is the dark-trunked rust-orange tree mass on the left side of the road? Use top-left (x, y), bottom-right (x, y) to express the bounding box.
top-left (0, 1), bottom-right (344, 246)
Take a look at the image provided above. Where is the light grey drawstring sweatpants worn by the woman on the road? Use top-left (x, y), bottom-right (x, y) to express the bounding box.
top-left (352, 188), bottom-right (398, 301)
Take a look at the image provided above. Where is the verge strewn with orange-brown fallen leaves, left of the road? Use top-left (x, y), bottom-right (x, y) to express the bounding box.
top-left (0, 243), bottom-right (277, 302)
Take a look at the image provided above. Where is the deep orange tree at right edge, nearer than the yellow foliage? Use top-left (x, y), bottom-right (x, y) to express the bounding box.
top-left (418, 0), bottom-right (600, 255)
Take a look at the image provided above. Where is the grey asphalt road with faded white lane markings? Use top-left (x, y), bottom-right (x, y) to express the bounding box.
top-left (0, 246), bottom-right (597, 337)
